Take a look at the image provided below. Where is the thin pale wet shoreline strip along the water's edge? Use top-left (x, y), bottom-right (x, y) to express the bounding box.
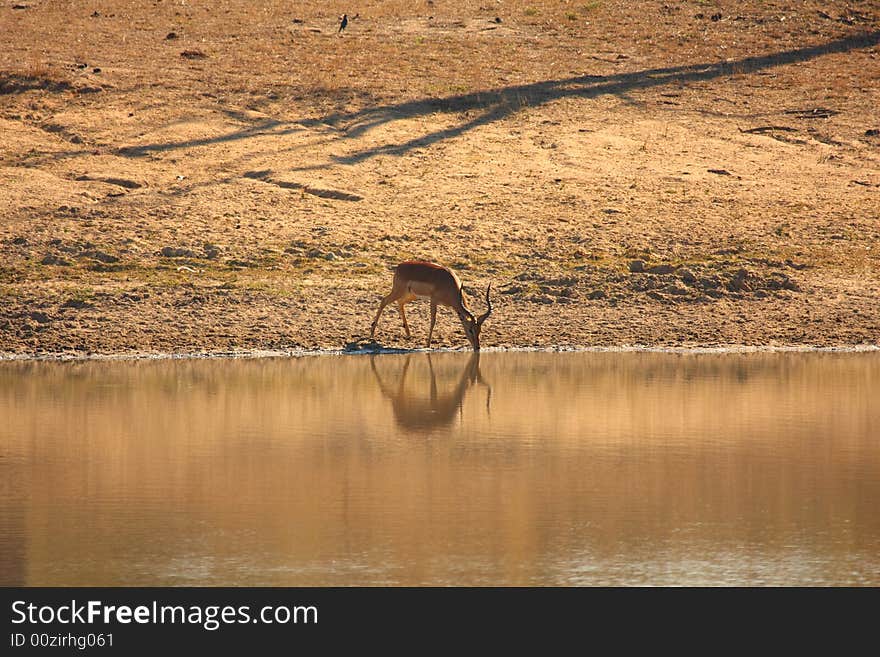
top-left (0, 344), bottom-right (880, 365)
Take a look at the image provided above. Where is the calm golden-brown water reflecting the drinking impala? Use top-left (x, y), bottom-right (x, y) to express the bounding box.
top-left (0, 353), bottom-right (880, 586)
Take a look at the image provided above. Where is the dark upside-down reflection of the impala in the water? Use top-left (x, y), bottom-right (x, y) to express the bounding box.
top-left (370, 353), bottom-right (492, 429)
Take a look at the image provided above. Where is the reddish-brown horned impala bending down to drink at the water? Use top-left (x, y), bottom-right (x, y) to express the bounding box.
top-left (370, 261), bottom-right (492, 351)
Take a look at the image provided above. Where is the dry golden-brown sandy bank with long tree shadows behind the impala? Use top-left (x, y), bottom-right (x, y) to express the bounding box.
top-left (0, 0), bottom-right (880, 355)
